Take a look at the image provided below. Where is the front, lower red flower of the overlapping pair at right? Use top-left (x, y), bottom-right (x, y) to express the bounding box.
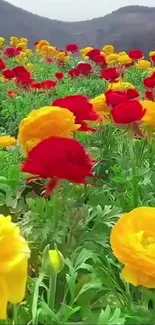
top-left (111, 100), bottom-right (146, 124)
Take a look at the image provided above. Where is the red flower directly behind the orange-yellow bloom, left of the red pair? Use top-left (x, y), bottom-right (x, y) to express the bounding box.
top-left (52, 95), bottom-right (99, 131)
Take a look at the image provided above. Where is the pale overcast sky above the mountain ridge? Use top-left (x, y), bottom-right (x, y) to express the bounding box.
top-left (7, 0), bottom-right (155, 21)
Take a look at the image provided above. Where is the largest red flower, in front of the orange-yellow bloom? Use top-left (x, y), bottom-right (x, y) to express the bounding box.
top-left (22, 137), bottom-right (93, 196)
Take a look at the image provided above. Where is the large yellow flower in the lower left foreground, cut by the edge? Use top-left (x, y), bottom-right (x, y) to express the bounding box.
top-left (0, 215), bottom-right (30, 320)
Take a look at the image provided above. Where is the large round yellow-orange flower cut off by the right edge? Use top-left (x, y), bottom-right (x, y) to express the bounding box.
top-left (110, 207), bottom-right (155, 288)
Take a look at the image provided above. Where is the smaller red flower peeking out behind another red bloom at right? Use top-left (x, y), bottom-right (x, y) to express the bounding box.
top-left (105, 90), bottom-right (128, 107)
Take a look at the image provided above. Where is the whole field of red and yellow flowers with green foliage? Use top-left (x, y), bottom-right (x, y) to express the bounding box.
top-left (0, 37), bottom-right (155, 325)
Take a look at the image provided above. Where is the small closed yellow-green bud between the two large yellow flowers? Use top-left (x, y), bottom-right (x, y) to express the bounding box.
top-left (49, 249), bottom-right (64, 273)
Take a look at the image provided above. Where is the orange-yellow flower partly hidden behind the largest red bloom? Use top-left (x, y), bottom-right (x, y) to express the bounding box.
top-left (18, 106), bottom-right (80, 155)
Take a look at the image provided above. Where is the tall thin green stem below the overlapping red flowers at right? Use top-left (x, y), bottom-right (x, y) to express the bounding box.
top-left (129, 134), bottom-right (139, 208)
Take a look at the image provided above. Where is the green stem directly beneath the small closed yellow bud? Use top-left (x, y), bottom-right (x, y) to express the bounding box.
top-left (48, 272), bottom-right (57, 310)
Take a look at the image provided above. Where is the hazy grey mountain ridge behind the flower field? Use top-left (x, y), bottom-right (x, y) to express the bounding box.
top-left (0, 0), bottom-right (155, 52)
